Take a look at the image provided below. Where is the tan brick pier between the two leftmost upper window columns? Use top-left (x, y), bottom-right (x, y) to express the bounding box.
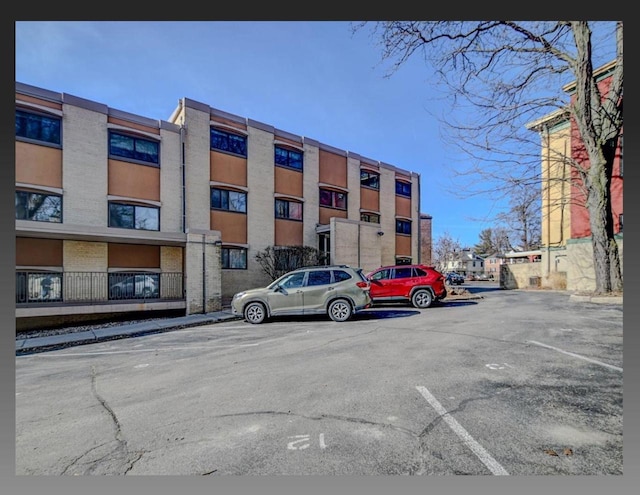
top-left (62, 105), bottom-right (108, 227)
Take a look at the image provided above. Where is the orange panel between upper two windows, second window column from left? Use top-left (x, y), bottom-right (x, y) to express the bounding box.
top-left (109, 160), bottom-right (160, 201)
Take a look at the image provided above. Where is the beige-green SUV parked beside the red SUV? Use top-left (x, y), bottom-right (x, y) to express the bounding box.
top-left (231, 265), bottom-right (371, 323)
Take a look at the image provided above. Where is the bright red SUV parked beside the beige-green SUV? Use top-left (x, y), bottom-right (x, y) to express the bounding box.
top-left (367, 265), bottom-right (447, 308)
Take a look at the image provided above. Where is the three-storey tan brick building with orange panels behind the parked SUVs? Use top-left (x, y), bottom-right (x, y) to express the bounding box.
top-left (15, 83), bottom-right (421, 327)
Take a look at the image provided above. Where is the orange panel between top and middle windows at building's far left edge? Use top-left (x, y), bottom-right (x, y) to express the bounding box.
top-left (16, 141), bottom-right (62, 188)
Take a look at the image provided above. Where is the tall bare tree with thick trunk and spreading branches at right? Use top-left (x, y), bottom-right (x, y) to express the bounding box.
top-left (354, 21), bottom-right (623, 293)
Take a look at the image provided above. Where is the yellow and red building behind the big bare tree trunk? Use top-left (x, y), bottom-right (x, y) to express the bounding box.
top-left (527, 62), bottom-right (624, 291)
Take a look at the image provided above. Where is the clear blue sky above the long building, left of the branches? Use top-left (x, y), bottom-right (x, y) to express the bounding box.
top-left (15, 21), bottom-right (560, 246)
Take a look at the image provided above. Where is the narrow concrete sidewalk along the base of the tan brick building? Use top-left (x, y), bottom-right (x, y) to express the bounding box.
top-left (16, 309), bottom-right (239, 355)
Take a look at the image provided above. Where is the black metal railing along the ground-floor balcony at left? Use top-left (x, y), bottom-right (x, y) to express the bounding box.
top-left (16, 271), bottom-right (185, 306)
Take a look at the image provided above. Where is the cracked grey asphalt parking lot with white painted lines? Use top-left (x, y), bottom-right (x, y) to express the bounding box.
top-left (16, 286), bottom-right (623, 476)
